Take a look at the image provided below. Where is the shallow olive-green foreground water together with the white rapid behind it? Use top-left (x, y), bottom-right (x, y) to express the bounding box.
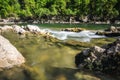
top-left (0, 24), bottom-right (118, 80)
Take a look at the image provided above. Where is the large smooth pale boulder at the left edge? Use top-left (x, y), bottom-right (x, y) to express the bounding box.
top-left (0, 35), bottom-right (25, 69)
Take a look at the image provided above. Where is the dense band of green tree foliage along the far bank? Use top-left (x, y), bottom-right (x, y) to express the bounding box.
top-left (0, 0), bottom-right (120, 20)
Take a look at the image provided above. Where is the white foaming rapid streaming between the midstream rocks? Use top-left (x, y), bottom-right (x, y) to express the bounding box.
top-left (38, 26), bottom-right (105, 42)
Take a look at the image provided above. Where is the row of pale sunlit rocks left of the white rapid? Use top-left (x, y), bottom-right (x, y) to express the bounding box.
top-left (0, 25), bottom-right (51, 36)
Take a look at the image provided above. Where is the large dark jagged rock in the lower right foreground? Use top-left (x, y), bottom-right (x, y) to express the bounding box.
top-left (75, 38), bottom-right (120, 74)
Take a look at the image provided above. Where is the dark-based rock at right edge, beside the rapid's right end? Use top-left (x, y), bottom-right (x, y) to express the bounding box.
top-left (96, 26), bottom-right (120, 37)
